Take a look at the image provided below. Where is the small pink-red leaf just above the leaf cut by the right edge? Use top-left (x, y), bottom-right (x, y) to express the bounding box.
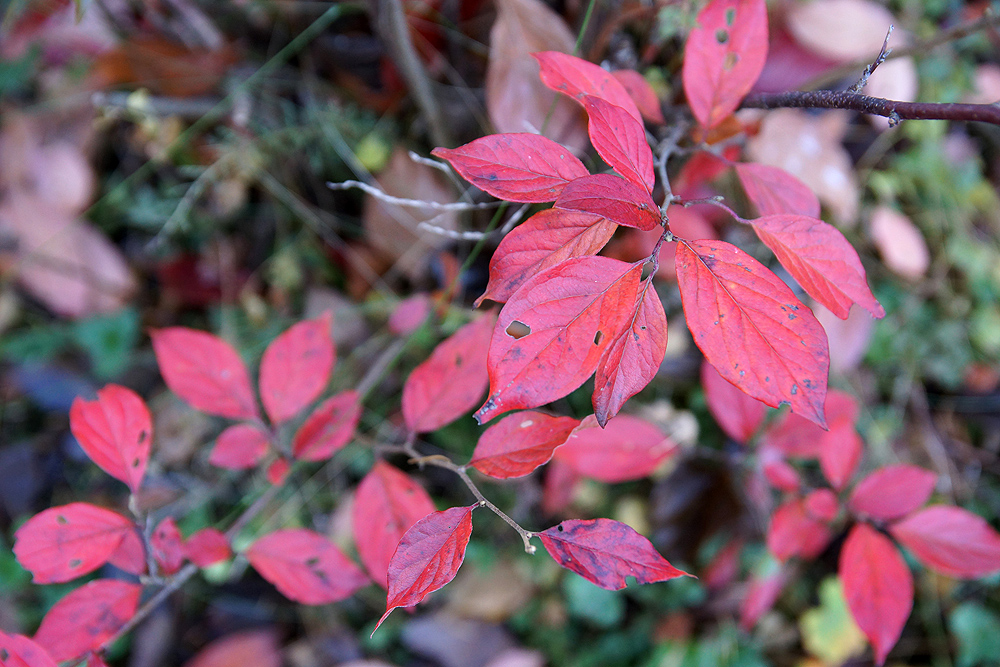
top-left (847, 465), bottom-right (937, 521)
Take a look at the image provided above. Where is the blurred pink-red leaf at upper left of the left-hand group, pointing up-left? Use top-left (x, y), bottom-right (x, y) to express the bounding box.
top-left (150, 327), bottom-right (257, 419)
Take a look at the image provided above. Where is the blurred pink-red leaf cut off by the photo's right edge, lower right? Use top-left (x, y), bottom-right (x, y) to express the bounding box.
top-left (889, 505), bottom-right (1000, 579)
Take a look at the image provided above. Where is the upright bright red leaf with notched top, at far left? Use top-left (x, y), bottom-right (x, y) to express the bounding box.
top-left (69, 384), bottom-right (153, 493)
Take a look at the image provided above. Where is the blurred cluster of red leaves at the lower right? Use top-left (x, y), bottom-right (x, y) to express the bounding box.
top-left (702, 365), bottom-right (1000, 664)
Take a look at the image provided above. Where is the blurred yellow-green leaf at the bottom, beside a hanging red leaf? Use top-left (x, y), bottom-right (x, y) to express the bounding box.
top-left (799, 577), bottom-right (868, 665)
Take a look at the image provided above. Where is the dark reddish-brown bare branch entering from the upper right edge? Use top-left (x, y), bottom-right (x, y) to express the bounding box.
top-left (741, 90), bottom-right (1000, 125)
